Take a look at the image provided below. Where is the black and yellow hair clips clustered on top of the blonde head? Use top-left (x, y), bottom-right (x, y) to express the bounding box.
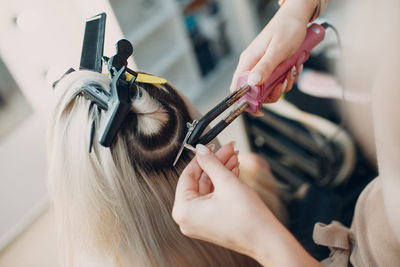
top-left (53, 13), bottom-right (167, 153)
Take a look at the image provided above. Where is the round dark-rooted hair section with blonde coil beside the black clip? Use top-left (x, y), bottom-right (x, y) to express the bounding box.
top-left (115, 75), bottom-right (192, 169)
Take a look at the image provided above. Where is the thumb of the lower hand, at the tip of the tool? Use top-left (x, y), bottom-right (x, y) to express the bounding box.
top-left (196, 144), bottom-right (234, 186)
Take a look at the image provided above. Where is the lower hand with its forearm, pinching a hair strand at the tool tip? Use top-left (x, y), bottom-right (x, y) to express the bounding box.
top-left (172, 145), bottom-right (320, 266)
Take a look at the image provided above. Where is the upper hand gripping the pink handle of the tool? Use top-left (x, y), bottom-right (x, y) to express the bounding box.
top-left (230, 0), bottom-right (317, 103)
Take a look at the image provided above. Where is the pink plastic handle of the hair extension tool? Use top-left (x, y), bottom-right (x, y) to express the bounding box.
top-left (237, 23), bottom-right (325, 113)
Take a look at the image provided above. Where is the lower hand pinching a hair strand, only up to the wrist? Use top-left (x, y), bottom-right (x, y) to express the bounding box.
top-left (172, 145), bottom-right (277, 264)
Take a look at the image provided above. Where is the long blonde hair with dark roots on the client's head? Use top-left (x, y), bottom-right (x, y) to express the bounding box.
top-left (48, 71), bottom-right (268, 266)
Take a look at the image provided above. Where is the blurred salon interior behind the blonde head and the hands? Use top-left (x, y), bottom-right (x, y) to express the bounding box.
top-left (0, 0), bottom-right (377, 267)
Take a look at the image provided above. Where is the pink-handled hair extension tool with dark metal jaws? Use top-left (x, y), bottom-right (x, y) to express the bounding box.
top-left (174, 23), bottom-right (326, 165)
